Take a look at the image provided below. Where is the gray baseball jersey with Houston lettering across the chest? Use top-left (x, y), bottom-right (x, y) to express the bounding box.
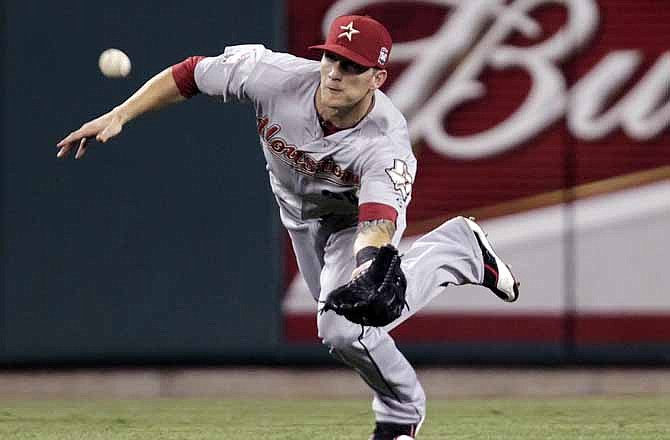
top-left (195, 45), bottom-right (416, 237)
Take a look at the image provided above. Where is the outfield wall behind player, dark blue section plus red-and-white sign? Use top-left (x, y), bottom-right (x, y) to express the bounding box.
top-left (0, 0), bottom-right (670, 367)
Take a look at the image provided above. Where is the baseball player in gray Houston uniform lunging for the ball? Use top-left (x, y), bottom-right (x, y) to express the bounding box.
top-left (58, 16), bottom-right (518, 440)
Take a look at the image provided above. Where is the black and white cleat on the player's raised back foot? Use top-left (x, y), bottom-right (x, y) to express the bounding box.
top-left (463, 217), bottom-right (520, 302)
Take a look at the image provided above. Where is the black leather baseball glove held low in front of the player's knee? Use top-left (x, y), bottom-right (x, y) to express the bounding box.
top-left (321, 244), bottom-right (409, 327)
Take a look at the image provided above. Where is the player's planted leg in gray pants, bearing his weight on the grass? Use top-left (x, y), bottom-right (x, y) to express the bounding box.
top-left (317, 228), bottom-right (425, 433)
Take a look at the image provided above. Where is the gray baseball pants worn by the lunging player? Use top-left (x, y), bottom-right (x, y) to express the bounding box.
top-left (289, 217), bottom-right (484, 424)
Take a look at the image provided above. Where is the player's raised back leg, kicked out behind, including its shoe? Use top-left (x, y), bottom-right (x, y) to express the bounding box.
top-left (385, 217), bottom-right (519, 331)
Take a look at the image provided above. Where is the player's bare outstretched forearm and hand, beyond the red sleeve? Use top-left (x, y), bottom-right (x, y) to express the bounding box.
top-left (56, 68), bottom-right (185, 159)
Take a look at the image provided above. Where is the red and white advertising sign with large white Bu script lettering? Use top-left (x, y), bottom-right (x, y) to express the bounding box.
top-left (284, 0), bottom-right (670, 343)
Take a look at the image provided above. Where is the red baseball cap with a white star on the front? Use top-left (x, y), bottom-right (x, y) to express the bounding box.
top-left (309, 15), bottom-right (393, 69)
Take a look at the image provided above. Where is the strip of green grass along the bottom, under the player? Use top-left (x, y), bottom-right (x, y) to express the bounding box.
top-left (0, 397), bottom-right (670, 440)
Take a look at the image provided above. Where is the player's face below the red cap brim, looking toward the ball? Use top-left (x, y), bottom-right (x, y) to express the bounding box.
top-left (320, 52), bottom-right (386, 108)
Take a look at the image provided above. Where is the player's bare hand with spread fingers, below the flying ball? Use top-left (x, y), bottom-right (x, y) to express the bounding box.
top-left (56, 109), bottom-right (124, 159)
